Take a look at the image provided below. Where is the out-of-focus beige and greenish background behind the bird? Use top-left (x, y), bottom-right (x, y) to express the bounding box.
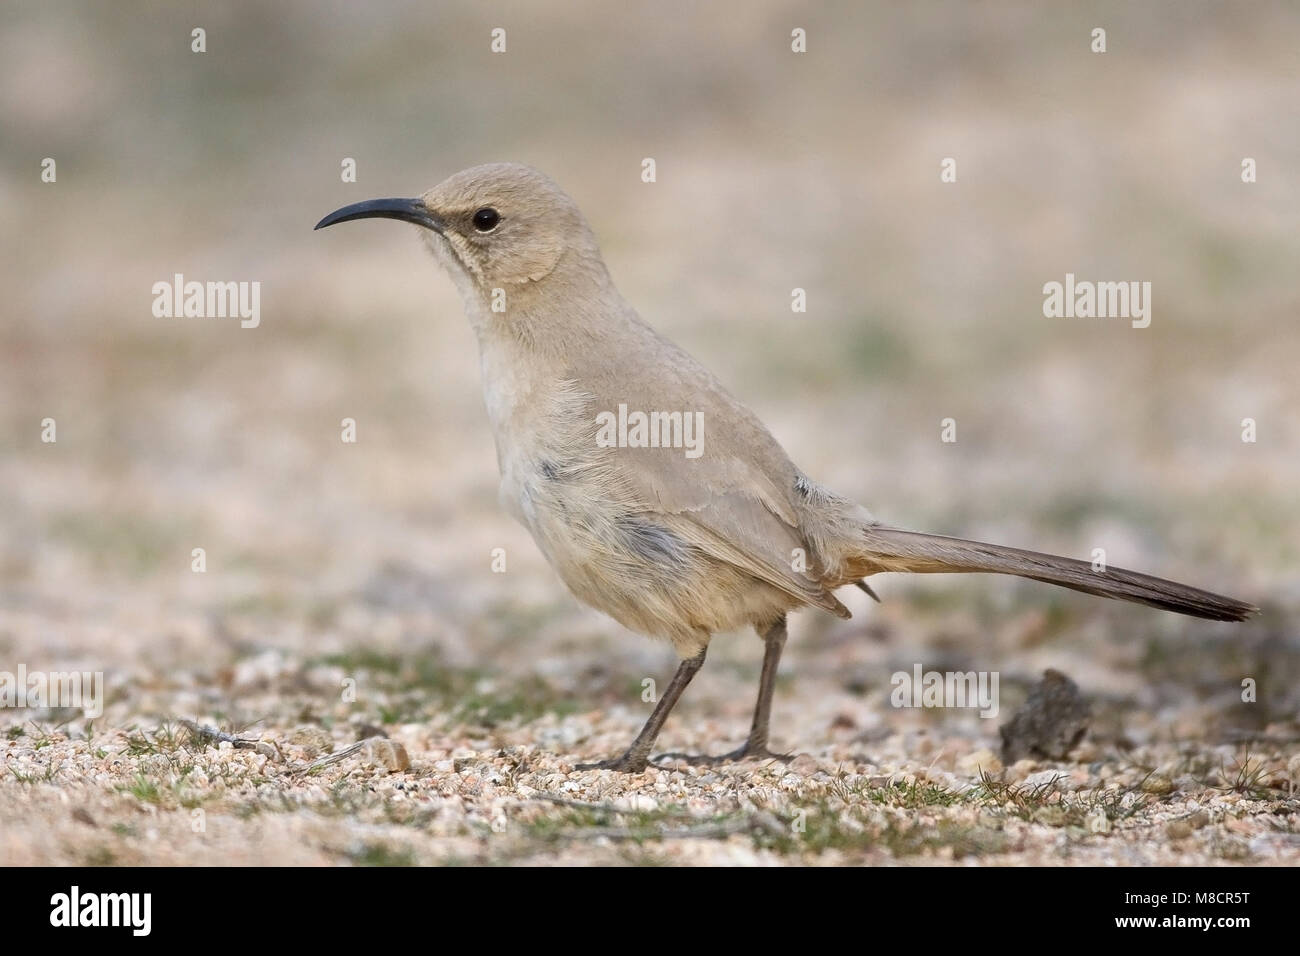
top-left (0, 0), bottom-right (1300, 790)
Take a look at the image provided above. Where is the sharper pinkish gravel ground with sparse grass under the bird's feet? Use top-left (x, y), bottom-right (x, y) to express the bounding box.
top-left (0, 598), bottom-right (1300, 865)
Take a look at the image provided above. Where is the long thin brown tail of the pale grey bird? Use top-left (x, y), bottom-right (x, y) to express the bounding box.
top-left (854, 525), bottom-right (1260, 620)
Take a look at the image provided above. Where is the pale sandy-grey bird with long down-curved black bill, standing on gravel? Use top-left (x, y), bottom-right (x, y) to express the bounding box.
top-left (316, 163), bottom-right (1258, 773)
